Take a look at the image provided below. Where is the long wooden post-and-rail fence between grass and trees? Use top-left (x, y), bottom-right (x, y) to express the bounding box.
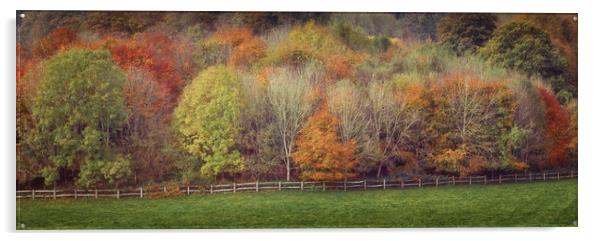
top-left (16, 171), bottom-right (577, 199)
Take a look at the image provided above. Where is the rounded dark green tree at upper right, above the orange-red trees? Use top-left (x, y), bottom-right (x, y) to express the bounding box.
top-left (481, 22), bottom-right (574, 95)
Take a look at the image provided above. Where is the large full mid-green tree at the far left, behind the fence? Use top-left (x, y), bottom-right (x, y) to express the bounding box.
top-left (27, 50), bottom-right (130, 186)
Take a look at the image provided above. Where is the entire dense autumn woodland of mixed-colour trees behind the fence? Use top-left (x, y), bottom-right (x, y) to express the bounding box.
top-left (16, 11), bottom-right (578, 187)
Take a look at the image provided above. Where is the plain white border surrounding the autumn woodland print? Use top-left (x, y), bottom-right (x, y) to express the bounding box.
top-left (0, 0), bottom-right (602, 241)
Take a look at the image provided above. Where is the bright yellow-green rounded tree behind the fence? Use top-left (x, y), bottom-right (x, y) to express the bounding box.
top-left (174, 65), bottom-right (243, 177)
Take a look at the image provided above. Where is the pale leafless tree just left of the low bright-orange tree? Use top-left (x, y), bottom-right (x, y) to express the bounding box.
top-left (267, 65), bottom-right (320, 181)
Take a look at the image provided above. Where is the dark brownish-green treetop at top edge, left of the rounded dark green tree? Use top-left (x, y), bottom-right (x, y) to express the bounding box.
top-left (437, 13), bottom-right (497, 55)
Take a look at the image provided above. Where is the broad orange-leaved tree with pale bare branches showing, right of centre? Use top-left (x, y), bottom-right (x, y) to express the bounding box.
top-left (430, 73), bottom-right (514, 175)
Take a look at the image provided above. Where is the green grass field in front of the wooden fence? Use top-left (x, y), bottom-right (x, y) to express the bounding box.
top-left (17, 180), bottom-right (577, 229)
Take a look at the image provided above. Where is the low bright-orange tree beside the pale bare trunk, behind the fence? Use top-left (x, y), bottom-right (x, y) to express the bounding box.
top-left (293, 101), bottom-right (357, 181)
